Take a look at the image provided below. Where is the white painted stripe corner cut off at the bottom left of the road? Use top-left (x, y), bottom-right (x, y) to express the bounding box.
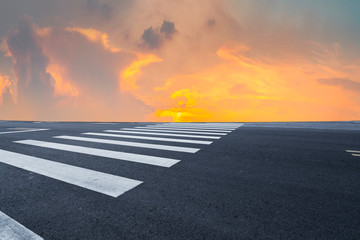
top-left (0, 212), bottom-right (43, 240)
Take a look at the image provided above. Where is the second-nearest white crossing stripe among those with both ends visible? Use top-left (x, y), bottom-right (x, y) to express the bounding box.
top-left (54, 136), bottom-right (200, 153)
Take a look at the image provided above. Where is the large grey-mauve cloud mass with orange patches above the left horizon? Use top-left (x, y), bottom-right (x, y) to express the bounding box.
top-left (0, 18), bottom-right (153, 121)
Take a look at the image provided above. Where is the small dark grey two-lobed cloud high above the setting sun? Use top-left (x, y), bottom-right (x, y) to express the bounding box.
top-left (141, 20), bottom-right (177, 49)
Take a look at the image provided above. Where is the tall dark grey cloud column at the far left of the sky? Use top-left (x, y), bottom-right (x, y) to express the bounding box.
top-left (6, 17), bottom-right (53, 103)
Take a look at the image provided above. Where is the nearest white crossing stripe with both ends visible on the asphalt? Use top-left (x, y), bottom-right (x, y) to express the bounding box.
top-left (15, 140), bottom-right (180, 167)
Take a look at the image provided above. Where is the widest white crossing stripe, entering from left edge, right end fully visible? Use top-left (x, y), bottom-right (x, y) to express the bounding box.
top-left (0, 149), bottom-right (142, 197)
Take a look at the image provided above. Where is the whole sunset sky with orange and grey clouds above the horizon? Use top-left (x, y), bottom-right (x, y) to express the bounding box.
top-left (0, 0), bottom-right (360, 122)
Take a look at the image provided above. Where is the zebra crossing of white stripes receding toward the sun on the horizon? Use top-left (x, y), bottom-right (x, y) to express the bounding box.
top-left (0, 123), bottom-right (242, 197)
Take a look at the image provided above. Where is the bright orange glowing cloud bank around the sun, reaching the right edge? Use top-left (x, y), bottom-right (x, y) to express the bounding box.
top-left (151, 43), bottom-right (360, 121)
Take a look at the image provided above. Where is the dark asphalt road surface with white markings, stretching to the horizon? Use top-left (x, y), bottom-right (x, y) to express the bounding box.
top-left (0, 121), bottom-right (360, 240)
